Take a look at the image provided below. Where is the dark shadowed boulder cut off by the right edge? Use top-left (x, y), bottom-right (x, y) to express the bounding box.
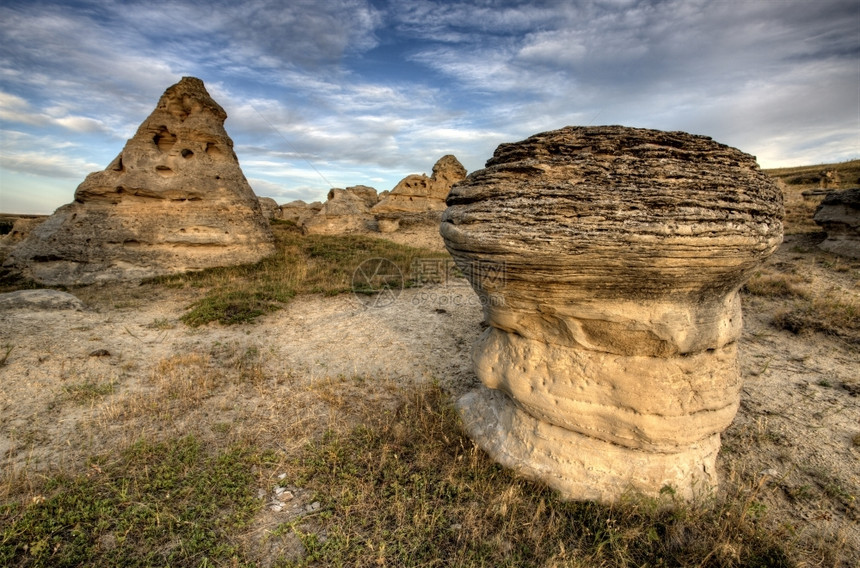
top-left (813, 188), bottom-right (860, 258)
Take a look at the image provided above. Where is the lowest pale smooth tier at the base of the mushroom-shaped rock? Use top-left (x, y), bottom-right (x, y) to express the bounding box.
top-left (457, 387), bottom-right (720, 502)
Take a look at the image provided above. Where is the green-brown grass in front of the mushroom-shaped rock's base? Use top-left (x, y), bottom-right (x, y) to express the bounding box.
top-left (288, 387), bottom-right (808, 567)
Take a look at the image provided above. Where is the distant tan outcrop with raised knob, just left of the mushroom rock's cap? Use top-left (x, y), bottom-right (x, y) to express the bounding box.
top-left (373, 154), bottom-right (466, 215)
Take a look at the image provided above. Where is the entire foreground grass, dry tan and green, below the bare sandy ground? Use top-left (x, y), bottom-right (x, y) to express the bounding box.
top-left (6, 345), bottom-right (839, 567)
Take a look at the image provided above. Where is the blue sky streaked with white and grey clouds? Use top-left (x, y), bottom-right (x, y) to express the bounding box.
top-left (0, 0), bottom-right (860, 213)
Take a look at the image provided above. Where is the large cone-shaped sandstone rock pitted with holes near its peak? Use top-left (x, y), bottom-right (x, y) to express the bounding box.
top-left (7, 77), bottom-right (274, 284)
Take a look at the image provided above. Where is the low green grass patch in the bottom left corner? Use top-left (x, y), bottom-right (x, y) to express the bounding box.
top-left (0, 437), bottom-right (268, 567)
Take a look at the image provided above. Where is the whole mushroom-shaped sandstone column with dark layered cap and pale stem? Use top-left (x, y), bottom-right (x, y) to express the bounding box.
top-left (441, 126), bottom-right (782, 501)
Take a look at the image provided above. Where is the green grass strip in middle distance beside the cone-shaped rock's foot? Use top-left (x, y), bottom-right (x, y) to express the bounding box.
top-left (147, 221), bottom-right (450, 326)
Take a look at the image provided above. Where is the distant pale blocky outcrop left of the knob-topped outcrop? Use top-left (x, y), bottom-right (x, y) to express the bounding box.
top-left (302, 185), bottom-right (376, 235)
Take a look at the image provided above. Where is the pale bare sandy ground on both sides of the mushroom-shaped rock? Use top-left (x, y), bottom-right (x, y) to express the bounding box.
top-left (0, 230), bottom-right (860, 559)
